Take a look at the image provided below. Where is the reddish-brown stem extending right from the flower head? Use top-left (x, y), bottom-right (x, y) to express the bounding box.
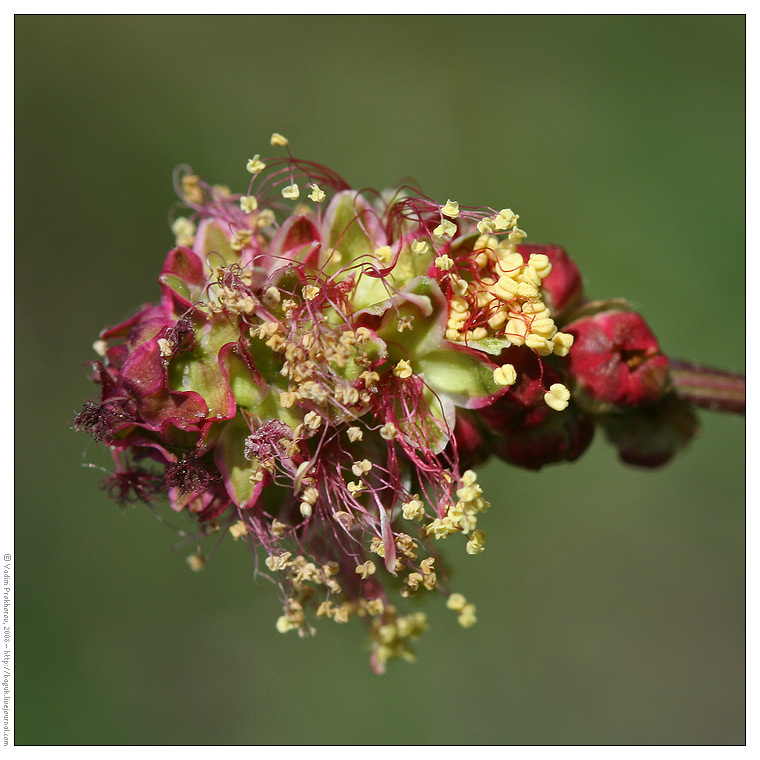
top-left (670, 359), bottom-right (745, 414)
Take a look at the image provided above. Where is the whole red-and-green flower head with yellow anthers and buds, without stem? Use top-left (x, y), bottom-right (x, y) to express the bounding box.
top-left (74, 135), bottom-right (744, 672)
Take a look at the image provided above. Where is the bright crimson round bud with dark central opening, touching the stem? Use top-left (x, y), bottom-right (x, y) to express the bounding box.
top-left (563, 311), bottom-right (670, 413)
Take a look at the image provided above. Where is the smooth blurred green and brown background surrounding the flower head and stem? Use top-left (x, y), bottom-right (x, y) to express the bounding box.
top-left (15, 16), bottom-right (745, 744)
